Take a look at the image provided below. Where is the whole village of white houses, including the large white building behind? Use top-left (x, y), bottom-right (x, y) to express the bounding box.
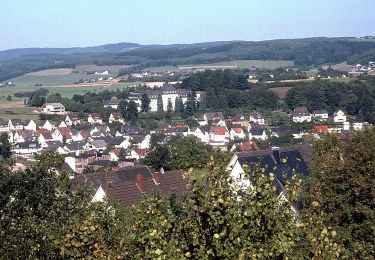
top-left (0, 87), bottom-right (370, 177)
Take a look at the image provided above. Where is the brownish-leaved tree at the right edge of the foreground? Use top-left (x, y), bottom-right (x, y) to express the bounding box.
top-left (305, 129), bottom-right (375, 259)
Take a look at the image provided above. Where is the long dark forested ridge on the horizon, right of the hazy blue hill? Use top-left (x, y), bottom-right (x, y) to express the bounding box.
top-left (115, 38), bottom-right (375, 66)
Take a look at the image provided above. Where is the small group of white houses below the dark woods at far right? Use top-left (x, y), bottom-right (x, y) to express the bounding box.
top-left (291, 107), bottom-right (369, 133)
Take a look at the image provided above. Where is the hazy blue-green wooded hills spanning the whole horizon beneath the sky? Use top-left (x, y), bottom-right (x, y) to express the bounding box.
top-left (0, 37), bottom-right (375, 81)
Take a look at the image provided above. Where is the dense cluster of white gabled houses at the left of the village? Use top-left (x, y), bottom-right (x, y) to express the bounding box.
top-left (0, 112), bottom-right (151, 172)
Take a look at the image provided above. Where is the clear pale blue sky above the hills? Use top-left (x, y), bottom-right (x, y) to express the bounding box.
top-left (0, 0), bottom-right (375, 50)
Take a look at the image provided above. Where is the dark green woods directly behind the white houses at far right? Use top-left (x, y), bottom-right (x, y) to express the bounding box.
top-left (285, 80), bottom-right (375, 123)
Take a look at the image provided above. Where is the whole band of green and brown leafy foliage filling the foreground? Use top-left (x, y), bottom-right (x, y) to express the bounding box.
top-left (0, 127), bottom-right (375, 259)
